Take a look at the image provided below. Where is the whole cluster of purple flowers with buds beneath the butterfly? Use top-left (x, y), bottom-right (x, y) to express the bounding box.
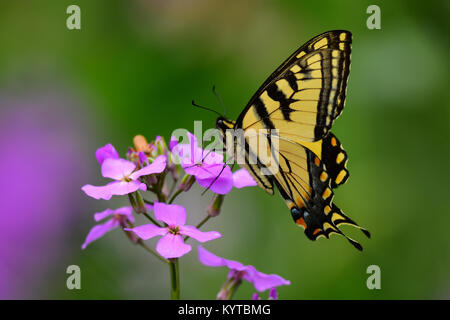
top-left (82, 133), bottom-right (289, 299)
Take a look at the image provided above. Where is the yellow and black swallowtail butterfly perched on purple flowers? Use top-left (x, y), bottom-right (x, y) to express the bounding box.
top-left (216, 30), bottom-right (370, 250)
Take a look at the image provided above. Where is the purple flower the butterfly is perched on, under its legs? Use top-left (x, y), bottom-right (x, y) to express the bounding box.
top-left (172, 132), bottom-right (256, 194)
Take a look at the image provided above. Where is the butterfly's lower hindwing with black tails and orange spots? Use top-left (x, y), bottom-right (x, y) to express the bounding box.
top-left (256, 136), bottom-right (370, 250)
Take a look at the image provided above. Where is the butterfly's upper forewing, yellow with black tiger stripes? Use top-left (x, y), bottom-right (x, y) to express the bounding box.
top-left (236, 30), bottom-right (352, 142)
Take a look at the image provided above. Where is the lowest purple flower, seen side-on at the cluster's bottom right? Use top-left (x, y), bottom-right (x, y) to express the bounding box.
top-left (198, 246), bottom-right (291, 292)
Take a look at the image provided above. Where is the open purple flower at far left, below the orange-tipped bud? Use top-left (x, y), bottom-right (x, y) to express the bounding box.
top-left (81, 155), bottom-right (167, 200)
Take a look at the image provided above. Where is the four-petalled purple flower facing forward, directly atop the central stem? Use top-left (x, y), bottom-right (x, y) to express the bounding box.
top-left (125, 202), bottom-right (222, 259)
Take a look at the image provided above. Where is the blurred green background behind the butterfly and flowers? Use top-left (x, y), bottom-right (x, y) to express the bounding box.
top-left (0, 0), bottom-right (450, 299)
